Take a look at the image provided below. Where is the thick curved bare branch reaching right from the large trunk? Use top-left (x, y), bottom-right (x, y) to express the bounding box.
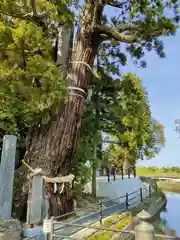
top-left (96, 25), bottom-right (137, 43)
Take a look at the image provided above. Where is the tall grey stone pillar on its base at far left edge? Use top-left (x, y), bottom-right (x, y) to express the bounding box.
top-left (0, 135), bottom-right (21, 240)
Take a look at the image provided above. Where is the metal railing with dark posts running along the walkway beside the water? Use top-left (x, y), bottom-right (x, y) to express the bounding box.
top-left (45, 184), bottom-right (157, 240)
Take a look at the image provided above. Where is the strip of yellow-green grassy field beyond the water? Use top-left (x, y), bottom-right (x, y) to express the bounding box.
top-left (136, 167), bottom-right (180, 178)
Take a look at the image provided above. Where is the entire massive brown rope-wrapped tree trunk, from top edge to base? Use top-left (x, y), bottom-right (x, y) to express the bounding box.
top-left (17, 1), bottom-right (101, 219)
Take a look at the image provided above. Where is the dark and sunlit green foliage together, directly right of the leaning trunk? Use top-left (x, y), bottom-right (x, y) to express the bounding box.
top-left (74, 68), bottom-right (165, 177)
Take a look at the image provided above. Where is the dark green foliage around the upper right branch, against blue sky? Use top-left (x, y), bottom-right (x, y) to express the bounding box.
top-left (102, 0), bottom-right (180, 74)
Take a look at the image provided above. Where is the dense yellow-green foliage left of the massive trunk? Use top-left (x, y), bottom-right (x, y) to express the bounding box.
top-left (0, 0), bottom-right (73, 137)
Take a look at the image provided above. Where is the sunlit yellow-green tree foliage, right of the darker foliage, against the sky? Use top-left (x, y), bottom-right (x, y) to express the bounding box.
top-left (104, 74), bottom-right (165, 168)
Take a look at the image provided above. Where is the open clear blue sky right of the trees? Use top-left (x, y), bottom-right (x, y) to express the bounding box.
top-left (123, 31), bottom-right (180, 166)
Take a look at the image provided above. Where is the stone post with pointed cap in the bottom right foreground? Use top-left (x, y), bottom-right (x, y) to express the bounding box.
top-left (135, 210), bottom-right (155, 240)
